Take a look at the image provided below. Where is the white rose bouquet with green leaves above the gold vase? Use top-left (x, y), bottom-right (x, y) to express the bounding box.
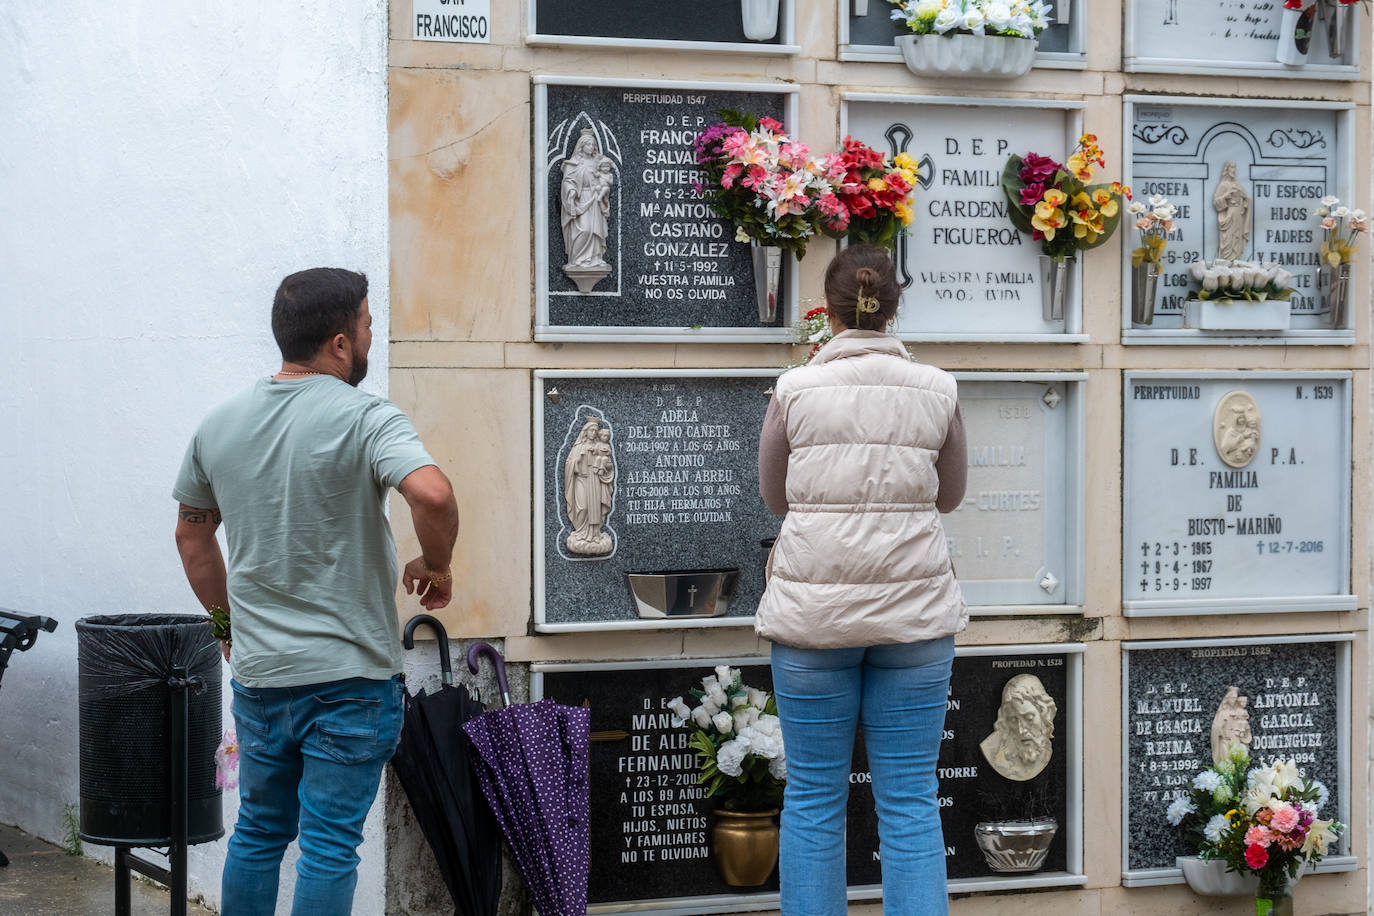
top-left (668, 665), bottom-right (787, 812)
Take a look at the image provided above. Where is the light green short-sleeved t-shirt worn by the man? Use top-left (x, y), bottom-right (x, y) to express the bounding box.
top-left (172, 376), bottom-right (434, 687)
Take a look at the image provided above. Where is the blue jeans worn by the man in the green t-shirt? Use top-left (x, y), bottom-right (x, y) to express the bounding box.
top-left (221, 677), bottom-right (404, 916)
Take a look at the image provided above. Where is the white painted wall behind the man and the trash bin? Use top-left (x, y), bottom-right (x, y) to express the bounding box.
top-left (0, 0), bottom-right (389, 913)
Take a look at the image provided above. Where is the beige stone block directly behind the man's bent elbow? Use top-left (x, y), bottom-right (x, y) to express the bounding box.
top-left (390, 368), bottom-right (532, 637)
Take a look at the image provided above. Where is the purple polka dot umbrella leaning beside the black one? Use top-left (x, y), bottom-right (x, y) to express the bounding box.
top-left (463, 643), bottom-right (591, 916)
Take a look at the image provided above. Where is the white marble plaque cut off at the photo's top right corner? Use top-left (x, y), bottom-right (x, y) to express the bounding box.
top-left (1125, 0), bottom-right (1352, 80)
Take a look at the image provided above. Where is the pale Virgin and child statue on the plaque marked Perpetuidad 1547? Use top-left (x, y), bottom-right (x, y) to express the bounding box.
top-left (558, 128), bottom-right (616, 293)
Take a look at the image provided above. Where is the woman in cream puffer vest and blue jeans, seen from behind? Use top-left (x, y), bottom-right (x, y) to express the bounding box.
top-left (754, 246), bottom-right (969, 916)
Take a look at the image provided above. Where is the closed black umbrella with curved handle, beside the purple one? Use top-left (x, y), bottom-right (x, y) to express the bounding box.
top-left (392, 614), bottom-right (502, 916)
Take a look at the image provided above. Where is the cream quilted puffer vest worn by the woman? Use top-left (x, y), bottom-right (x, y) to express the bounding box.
top-left (754, 331), bottom-right (969, 648)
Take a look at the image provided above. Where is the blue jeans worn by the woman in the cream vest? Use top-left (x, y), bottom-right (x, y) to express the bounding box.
top-left (772, 637), bottom-right (954, 916)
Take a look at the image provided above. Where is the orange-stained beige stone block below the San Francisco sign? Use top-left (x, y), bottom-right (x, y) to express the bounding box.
top-left (390, 69), bottom-right (532, 341)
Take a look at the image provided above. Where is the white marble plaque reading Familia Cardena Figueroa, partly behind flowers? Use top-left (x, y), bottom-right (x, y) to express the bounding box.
top-left (841, 97), bottom-right (1091, 341)
